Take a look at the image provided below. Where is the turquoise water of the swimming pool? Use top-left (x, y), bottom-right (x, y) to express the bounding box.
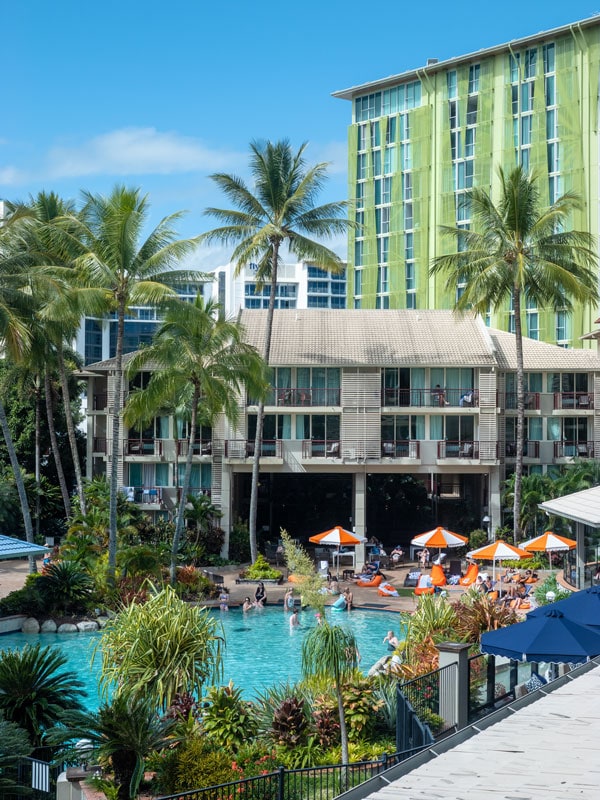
top-left (0, 606), bottom-right (400, 708)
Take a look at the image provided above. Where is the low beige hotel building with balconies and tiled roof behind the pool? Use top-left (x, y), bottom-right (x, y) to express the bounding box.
top-left (82, 309), bottom-right (600, 552)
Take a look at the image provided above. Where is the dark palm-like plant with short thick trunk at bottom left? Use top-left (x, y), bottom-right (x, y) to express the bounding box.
top-left (47, 693), bottom-right (175, 800)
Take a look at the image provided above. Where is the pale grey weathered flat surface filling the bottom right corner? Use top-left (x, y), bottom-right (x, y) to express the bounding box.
top-left (366, 667), bottom-right (600, 800)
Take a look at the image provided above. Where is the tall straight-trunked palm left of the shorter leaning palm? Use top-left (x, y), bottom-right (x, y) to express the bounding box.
top-left (54, 186), bottom-right (204, 584)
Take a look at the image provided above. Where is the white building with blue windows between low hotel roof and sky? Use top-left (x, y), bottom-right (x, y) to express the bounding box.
top-left (204, 262), bottom-right (347, 316)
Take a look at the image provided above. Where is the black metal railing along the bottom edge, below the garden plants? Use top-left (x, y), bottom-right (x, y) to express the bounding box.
top-left (156, 748), bottom-right (433, 800)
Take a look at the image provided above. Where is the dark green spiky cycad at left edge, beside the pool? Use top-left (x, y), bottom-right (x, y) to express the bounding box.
top-left (0, 644), bottom-right (84, 747)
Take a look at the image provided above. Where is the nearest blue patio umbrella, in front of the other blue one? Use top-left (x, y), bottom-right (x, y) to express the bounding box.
top-left (481, 607), bottom-right (600, 664)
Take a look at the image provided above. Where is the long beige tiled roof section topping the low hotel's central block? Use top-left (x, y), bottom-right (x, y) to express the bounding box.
top-left (241, 309), bottom-right (496, 367)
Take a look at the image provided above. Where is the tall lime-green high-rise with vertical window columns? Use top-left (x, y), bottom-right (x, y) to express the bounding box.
top-left (334, 17), bottom-right (600, 347)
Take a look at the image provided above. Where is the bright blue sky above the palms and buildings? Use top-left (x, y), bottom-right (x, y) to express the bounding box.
top-left (0, 0), bottom-right (599, 269)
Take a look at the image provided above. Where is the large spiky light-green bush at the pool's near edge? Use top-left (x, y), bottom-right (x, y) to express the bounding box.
top-left (99, 586), bottom-right (223, 708)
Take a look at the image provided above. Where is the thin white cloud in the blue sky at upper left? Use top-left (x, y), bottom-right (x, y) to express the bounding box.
top-left (46, 128), bottom-right (246, 178)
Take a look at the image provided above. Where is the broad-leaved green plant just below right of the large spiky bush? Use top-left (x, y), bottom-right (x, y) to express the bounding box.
top-left (202, 681), bottom-right (257, 752)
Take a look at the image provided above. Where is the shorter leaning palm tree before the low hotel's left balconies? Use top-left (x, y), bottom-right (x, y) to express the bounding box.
top-left (125, 294), bottom-right (266, 584)
